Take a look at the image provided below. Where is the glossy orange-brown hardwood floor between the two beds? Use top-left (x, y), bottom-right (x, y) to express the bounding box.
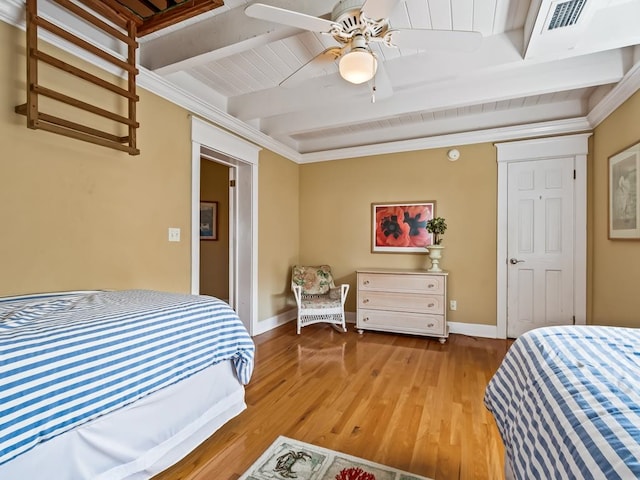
top-left (155, 323), bottom-right (511, 480)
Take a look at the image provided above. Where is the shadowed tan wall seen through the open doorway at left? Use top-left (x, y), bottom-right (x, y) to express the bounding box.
top-left (200, 159), bottom-right (229, 299)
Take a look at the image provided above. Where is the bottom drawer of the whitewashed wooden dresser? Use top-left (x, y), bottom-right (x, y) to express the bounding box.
top-left (356, 309), bottom-right (445, 335)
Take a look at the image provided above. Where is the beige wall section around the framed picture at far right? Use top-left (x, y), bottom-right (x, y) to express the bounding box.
top-left (589, 92), bottom-right (640, 327)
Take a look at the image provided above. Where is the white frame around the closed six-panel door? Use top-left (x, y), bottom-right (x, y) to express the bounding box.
top-left (494, 133), bottom-right (591, 338)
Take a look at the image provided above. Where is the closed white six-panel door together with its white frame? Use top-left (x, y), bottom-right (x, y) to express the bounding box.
top-left (495, 133), bottom-right (591, 338)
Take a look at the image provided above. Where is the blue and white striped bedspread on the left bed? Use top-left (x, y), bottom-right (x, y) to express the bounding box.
top-left (0, 290), bottom-right (255, 464)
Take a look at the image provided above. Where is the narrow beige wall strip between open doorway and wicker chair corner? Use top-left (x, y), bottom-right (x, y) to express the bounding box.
top-left (258, 150), bottom-right (300, 320)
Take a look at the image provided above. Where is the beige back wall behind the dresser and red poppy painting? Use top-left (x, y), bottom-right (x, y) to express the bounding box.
top-left (300, 143), bottom-right (497, 325)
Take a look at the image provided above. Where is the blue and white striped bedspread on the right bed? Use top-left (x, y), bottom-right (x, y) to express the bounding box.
top-left (484, 326), bottom-right (640, 480)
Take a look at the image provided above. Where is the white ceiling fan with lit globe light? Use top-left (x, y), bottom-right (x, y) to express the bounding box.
top-left (245, 0), bottom-right (482, 89)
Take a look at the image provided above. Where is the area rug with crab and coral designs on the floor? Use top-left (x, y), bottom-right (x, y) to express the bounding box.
top-left (238, 436), bottom-right (430, 480)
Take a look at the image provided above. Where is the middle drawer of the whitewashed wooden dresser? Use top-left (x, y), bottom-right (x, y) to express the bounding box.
top-left (358, 290), bottom-right (445, 314)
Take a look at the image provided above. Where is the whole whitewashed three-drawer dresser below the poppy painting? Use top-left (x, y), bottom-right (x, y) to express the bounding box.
top-left (356, 269), bottom-right (449, 343)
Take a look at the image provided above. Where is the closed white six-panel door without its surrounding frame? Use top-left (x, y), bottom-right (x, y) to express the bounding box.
top-left (507, 157), bottom-right (574, 337)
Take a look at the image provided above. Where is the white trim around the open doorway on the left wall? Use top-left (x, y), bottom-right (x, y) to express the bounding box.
top-left (191, 116), bottom-right (261, 335)
